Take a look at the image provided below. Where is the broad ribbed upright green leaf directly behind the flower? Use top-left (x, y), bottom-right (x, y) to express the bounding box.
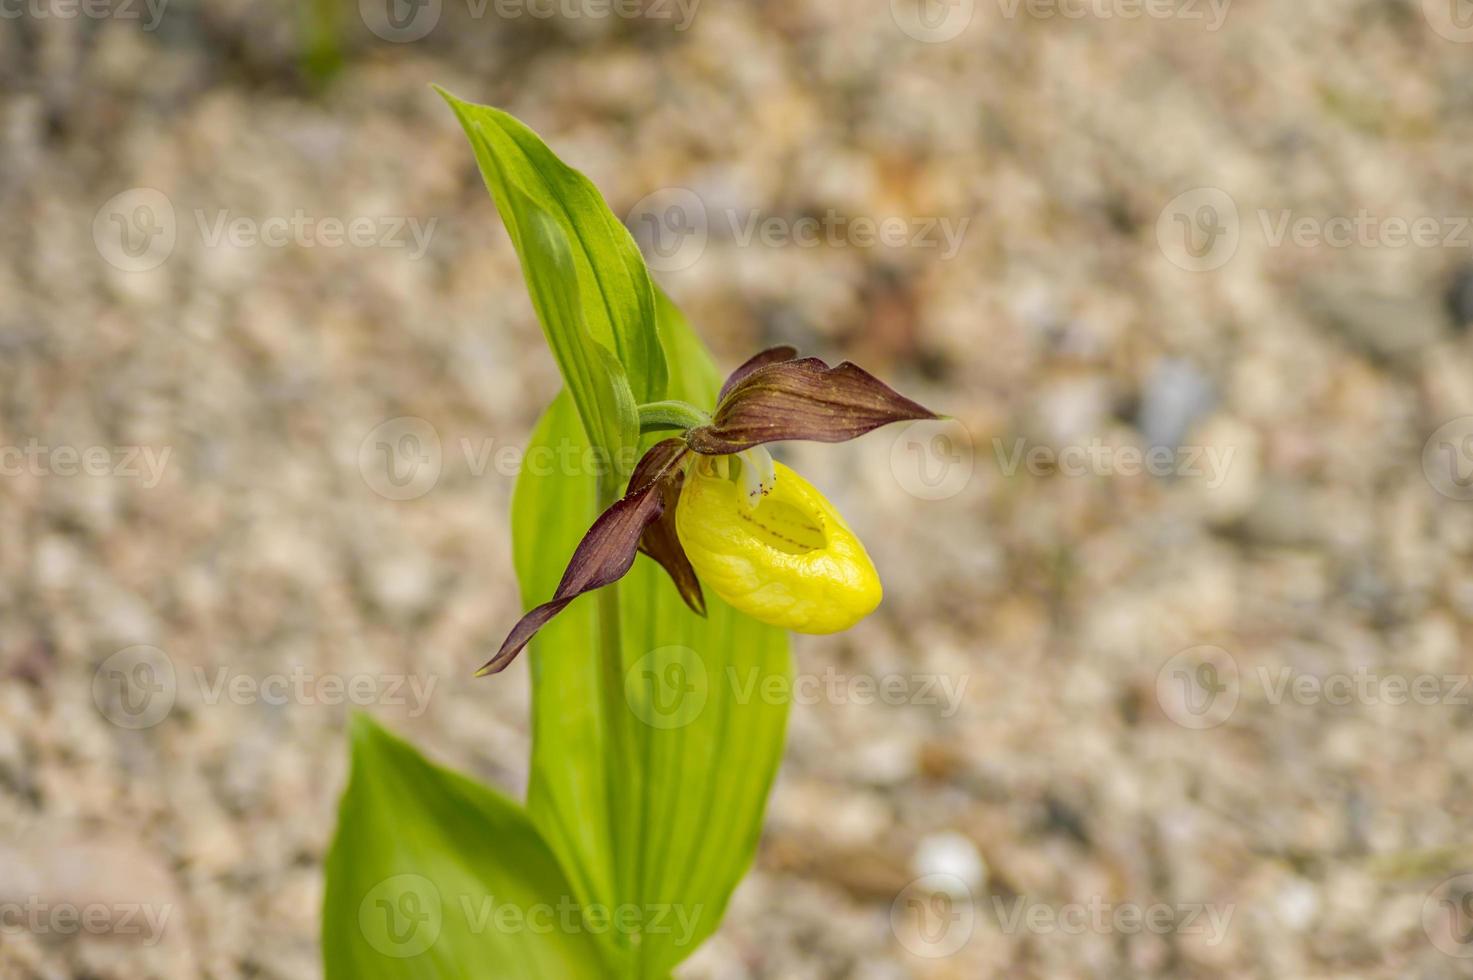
top-left (513, 295), bottom-right (791, 977)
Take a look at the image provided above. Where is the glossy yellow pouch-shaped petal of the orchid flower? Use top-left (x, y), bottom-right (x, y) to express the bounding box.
top-left (675, 458), bottom-right (882, 634)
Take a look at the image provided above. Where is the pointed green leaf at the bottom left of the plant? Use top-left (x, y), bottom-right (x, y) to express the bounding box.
top-left (323, 715), bottom-right (613, 980)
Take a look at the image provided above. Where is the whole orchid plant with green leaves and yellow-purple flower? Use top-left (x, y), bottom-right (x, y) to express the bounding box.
top-left (323, 91), bottom-right (937, 980)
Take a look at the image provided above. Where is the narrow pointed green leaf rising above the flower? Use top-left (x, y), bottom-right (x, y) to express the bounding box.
top-left (437, 88), bottom-right (667, 459)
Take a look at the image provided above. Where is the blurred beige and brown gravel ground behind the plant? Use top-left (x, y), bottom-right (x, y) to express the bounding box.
top-left (0, 0), bottom-right (1473, 980)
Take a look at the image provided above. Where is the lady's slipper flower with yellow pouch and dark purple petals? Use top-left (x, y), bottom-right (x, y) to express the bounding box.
top-left (477, 346), bottom-right (938, 675)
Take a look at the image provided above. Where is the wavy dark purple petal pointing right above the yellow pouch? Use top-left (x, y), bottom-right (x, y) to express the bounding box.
top-left (685, 357), bottom-right (937, 455)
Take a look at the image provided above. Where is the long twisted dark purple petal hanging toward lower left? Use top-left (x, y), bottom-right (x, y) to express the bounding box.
top-left (476, 439), bottom-right (685, 676)
